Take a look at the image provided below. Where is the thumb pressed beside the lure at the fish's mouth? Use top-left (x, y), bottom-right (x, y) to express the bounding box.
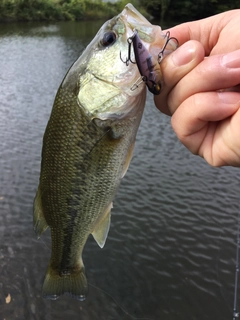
top-left (154, 41), bottom-right (204, 115)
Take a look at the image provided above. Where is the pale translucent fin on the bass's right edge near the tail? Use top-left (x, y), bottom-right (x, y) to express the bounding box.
top-left (92, 202), bottom-right (112, 248)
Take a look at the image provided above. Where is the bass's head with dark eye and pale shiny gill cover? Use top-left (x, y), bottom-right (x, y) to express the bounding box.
top-left (63, 4), bottom-right (172, 120)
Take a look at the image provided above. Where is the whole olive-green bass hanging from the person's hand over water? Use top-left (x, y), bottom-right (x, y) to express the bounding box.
top-left (33, 4), bottom-right (177, 301)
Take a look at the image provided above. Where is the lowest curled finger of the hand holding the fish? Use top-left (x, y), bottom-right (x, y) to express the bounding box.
top-left (171, 92), bottom-right (240, 166)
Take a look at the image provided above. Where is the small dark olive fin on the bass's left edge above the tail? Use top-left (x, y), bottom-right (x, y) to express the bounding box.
top-left (33, 187), bottom-right (48, 238)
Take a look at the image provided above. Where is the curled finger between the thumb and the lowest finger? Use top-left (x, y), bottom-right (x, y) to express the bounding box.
top-left (167, 50), bottom-right (240, 114)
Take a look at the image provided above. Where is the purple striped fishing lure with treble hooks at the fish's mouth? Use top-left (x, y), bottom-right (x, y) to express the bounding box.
top-left (120, 30), bottom-right (178, 95)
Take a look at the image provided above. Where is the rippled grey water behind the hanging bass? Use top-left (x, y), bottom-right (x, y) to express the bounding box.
top-left (0, 22), bottom-right (239, 320)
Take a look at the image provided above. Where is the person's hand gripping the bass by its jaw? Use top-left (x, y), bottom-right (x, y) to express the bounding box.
top-left (154, 10), bottom-right (240, 167)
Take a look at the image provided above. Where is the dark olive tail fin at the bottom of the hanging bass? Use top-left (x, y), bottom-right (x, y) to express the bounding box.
top-left (42, 265), bottom-right (87, 301)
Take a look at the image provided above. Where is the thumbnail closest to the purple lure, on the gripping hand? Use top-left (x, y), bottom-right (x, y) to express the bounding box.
top-left (172, 42), bottom-right (196, 67)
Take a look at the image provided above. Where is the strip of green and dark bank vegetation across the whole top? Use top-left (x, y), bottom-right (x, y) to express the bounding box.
top-left (0, 0), bottom-right (239, 22)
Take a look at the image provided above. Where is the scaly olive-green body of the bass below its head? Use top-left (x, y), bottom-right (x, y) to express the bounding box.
top-left (35, 84), bottom-right (145, 300)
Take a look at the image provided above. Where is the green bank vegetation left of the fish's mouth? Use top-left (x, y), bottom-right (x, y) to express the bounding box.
top-left (0, 0), bottom-right (142, 22)
